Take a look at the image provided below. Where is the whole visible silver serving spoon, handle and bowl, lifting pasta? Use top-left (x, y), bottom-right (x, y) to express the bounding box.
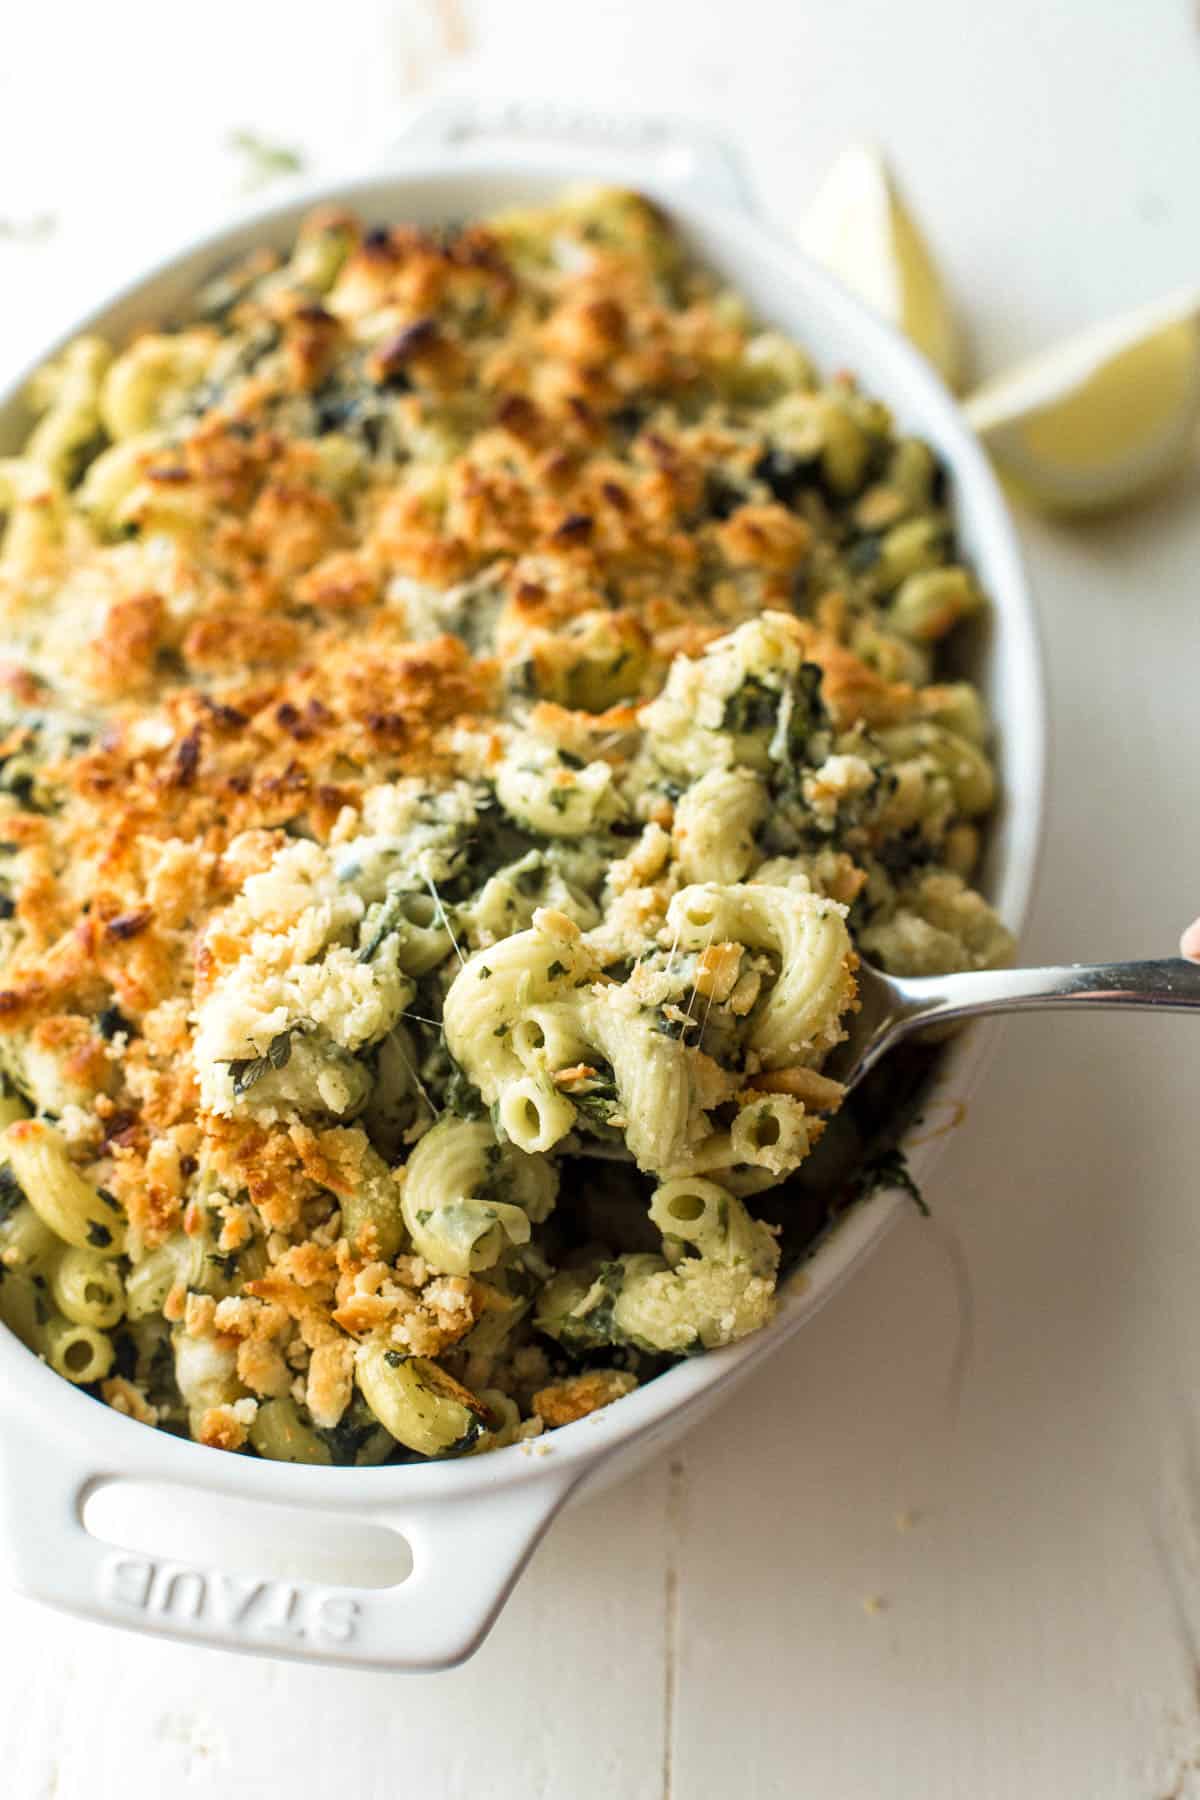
top-left (820, 956), bottom-right (1200, 1089)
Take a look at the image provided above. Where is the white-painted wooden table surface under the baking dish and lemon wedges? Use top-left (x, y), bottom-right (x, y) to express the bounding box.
top-left (0, 0), bottom-right (1200, 1800)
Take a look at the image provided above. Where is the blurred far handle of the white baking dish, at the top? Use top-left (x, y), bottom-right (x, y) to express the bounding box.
top-left (390, 94), bottom-right (752, 211)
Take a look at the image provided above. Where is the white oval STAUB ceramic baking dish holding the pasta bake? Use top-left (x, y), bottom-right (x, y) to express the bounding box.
top-left (0, 101), bottom-right (1045, 1670)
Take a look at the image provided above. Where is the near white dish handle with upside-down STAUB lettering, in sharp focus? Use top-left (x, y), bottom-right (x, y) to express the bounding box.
top-left (0, 1417), bottom-right (569, 1670)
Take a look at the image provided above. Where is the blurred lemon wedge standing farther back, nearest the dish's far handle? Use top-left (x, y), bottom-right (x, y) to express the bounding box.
top-left (799, 144), bottom-right (961, 387)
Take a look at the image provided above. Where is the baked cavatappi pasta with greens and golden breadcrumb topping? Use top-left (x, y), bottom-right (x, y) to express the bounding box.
top-left (0, 193), bottom-right (1009, 1465)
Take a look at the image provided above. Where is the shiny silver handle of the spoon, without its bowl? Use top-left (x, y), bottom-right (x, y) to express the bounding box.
top-left (891, 956), bottom-right (1200, 1031)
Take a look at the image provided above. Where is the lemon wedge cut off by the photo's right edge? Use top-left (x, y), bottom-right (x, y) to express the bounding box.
top-left (964, 290), bottom-right (1200, 511)
